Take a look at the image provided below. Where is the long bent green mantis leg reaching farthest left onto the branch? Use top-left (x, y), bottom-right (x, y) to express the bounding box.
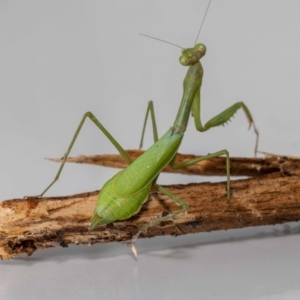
top-left (26, 112), bottom-right (132, 198)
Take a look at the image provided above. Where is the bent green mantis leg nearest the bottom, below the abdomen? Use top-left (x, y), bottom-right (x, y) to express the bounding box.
top-left (130, 184), bottom-right (189, 245)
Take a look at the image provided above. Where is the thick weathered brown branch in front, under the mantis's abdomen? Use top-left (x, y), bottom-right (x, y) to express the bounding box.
top-left (0, 157), bottom-right (300, 259)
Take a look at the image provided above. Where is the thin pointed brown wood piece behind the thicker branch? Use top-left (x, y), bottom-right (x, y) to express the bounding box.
top-left (48, 150), bottom-right (300, 176)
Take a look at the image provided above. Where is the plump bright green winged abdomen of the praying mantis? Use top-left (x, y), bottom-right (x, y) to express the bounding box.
top-left (91, 128), bottom-right (183, 229)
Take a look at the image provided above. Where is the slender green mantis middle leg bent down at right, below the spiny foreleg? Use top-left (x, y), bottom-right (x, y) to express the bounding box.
top-left (170, 149), bottom-right (233, 212)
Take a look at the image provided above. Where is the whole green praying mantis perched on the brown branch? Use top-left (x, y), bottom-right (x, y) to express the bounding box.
top-left (27, 0), bottom-right (258, 255)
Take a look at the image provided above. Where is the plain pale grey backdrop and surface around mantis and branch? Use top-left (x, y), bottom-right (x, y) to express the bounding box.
top-left (0, 0), bottom-right (300, 300)
